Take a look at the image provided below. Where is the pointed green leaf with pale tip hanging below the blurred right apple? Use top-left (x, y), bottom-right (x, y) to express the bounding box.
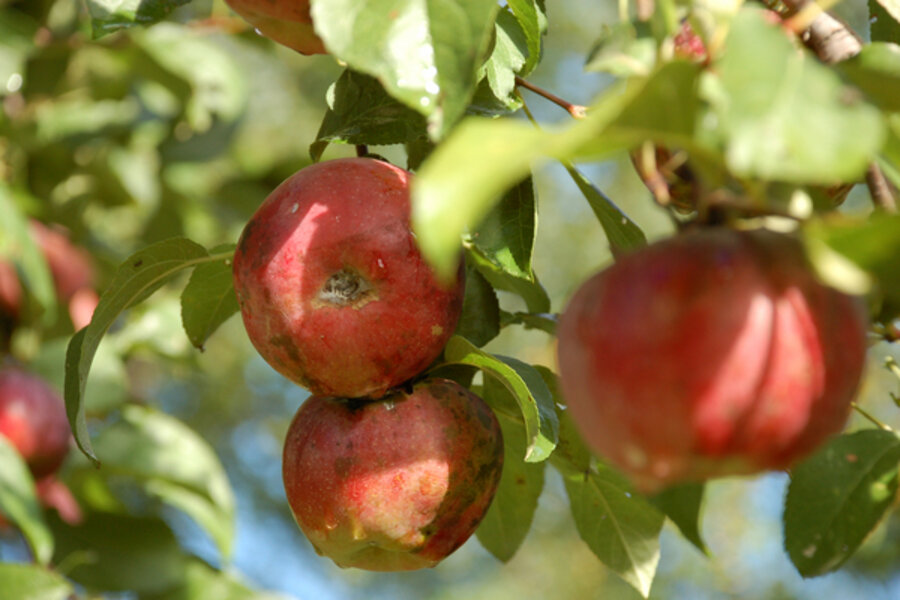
top-left (551, 413), bottom-right (665, 598)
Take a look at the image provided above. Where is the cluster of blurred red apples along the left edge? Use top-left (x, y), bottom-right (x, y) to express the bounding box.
top-left (0, 220), bottom-right (98, 523)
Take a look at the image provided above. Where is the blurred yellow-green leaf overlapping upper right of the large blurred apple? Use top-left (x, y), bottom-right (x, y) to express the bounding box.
top-left (805, 214), bottom-right (900, 318)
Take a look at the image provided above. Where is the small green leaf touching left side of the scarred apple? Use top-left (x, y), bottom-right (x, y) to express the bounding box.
top-left (181, 244), bottom-right (240, 350)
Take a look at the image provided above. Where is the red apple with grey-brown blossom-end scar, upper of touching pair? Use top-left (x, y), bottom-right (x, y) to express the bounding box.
top-left (233, 158), bottom-right (464, 398)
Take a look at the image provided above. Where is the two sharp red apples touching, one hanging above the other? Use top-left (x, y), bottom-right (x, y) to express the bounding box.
top-left (233, 158), bottom-right (503, 571)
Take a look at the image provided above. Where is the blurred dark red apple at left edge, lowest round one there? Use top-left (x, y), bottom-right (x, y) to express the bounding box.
top-left (0, 367), bottom-right (71, 479)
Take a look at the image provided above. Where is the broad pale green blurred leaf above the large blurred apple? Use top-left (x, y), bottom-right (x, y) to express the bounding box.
top-left (712, 8), bottom-right (884, 184)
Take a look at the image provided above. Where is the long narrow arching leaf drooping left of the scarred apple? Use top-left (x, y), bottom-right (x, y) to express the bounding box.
top-left (65, 238), bottom-right (209, 462)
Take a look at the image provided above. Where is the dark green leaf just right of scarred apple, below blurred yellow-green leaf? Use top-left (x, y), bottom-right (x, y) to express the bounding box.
top-left (466, 177), bottom-right (550, 312)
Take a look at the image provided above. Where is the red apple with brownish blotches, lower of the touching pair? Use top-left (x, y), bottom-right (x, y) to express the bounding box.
top-left (282, 379), bottom-right (503, 571)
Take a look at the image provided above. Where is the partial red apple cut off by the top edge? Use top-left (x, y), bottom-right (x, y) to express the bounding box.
top-left (225, 0), bottom-right (328, 54)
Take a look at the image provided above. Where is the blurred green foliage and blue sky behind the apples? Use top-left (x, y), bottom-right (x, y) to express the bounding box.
top-left (0, 0), bottom-right (900, 600)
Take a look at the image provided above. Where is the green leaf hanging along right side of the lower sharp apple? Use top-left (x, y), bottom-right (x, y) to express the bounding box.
top-left (475, 377), bottom-right (546, 562)
